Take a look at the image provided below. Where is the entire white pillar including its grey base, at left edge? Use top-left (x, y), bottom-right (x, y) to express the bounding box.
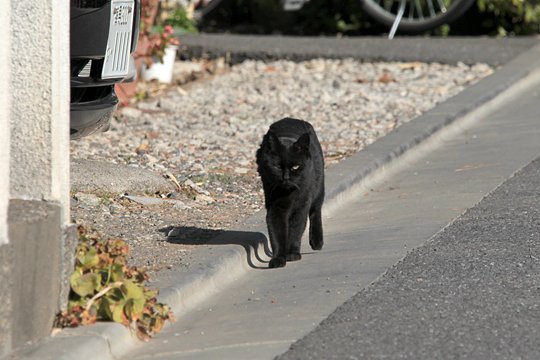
top-left (0, 0), bottom-right (72, 357)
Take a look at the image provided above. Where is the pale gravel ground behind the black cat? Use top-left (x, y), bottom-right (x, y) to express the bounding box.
top-left (71, 59), bottom-right (493, 271)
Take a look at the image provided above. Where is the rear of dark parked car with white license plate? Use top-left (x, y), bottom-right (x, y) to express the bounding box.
top-left (70, 0), bottom-right (141, 139)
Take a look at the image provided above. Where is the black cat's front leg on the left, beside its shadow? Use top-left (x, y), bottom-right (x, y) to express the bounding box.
top-left (266, 209), bottom-right (288, 268)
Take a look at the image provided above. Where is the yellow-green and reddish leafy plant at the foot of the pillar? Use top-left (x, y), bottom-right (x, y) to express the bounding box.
top-left (56, 226), bottom-right (174, 340)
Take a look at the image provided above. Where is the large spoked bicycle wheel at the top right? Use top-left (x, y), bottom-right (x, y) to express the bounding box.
top-left (360, 0), bottom-right (475, 33)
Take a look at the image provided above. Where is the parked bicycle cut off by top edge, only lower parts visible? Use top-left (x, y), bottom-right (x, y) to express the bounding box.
top-left (196, 0), bottom-right (475, 39)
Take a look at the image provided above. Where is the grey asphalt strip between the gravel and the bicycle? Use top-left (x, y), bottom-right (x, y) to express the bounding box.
top-left (180, 34), bottom-right (539, 66)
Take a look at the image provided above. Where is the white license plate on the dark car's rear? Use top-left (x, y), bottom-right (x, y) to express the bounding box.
top-left (101, 0), bottom-right (135, 79)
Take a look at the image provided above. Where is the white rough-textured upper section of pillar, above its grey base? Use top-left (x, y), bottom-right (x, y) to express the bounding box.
top-left (9, 0), bottom-right (70, 224)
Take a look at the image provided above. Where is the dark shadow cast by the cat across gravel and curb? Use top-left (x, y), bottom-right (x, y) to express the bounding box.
top-left (159, 226), bottom-right (272, 269)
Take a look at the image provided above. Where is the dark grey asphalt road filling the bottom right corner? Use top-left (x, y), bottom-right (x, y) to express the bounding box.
top-left (280, 158), bottom-right (540, 360)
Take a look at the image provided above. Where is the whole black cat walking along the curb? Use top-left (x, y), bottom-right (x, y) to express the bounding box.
top-left (257, 118), bottom-right (324, 268)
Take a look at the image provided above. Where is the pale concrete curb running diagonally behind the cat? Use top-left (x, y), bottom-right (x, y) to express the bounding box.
top-left (12, 40), bottom-right (540, 359)
